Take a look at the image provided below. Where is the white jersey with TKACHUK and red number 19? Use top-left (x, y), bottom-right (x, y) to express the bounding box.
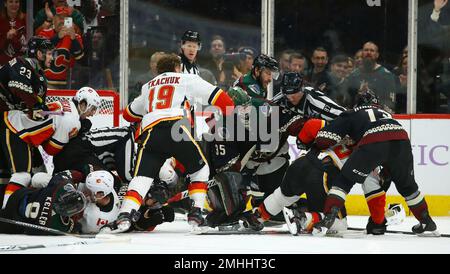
top-left (124, 72), bottom-right (233, 130)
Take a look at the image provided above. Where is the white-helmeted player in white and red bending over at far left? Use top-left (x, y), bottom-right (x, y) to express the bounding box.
top-left (3, 85), bottom-right (100, 207)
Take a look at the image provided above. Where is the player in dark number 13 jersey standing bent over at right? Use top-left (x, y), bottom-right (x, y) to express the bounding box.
top-left (313, 91), bottom-right (439, 236)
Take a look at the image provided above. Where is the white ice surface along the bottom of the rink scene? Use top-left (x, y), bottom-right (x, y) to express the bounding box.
top-left (0, 216), bottom-right (450, 254)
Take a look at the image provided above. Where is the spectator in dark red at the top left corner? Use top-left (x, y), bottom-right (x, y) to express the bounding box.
top-left (0, 0), bottom-right (27, 66)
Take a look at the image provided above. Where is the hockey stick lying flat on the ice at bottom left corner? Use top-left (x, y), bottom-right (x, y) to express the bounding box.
top-left (0, 234), bottom-right (130, 252)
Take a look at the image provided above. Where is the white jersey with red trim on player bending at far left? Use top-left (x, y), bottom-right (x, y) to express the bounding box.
top-left (4, 101), bottom-right (81, 155)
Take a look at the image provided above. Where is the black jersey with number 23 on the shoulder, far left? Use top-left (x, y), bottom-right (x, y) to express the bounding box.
top-left (0, 57), bottom-right (47, 111)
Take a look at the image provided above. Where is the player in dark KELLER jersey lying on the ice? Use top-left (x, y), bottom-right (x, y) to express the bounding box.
top-left (0, 171), bottom-right (87, 235)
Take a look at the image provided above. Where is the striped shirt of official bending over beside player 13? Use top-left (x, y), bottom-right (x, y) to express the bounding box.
top-left (272, 86), bottom-right (346, 121)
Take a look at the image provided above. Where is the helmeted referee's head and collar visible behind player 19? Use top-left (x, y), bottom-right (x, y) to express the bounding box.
top-left (180, 30), bottom-right (202, 75)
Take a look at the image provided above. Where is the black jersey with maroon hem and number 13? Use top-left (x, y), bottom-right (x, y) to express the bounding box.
top-left (316, 106), bottom-right (409, 149)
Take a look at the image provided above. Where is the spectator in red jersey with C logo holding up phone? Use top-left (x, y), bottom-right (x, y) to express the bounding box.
top-left (39, 8), bottom-right (84, 89)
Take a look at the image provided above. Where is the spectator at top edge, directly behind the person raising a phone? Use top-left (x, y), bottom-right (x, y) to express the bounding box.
top-left (34, 0), bottom-right (85, 35)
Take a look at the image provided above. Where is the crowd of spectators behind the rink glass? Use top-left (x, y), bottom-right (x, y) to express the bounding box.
top-left (0, 0), bottom-right (450, 113)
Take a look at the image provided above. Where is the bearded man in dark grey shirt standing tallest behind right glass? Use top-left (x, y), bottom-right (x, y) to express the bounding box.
top-left (344, 42), bottom-right (397, 110)
